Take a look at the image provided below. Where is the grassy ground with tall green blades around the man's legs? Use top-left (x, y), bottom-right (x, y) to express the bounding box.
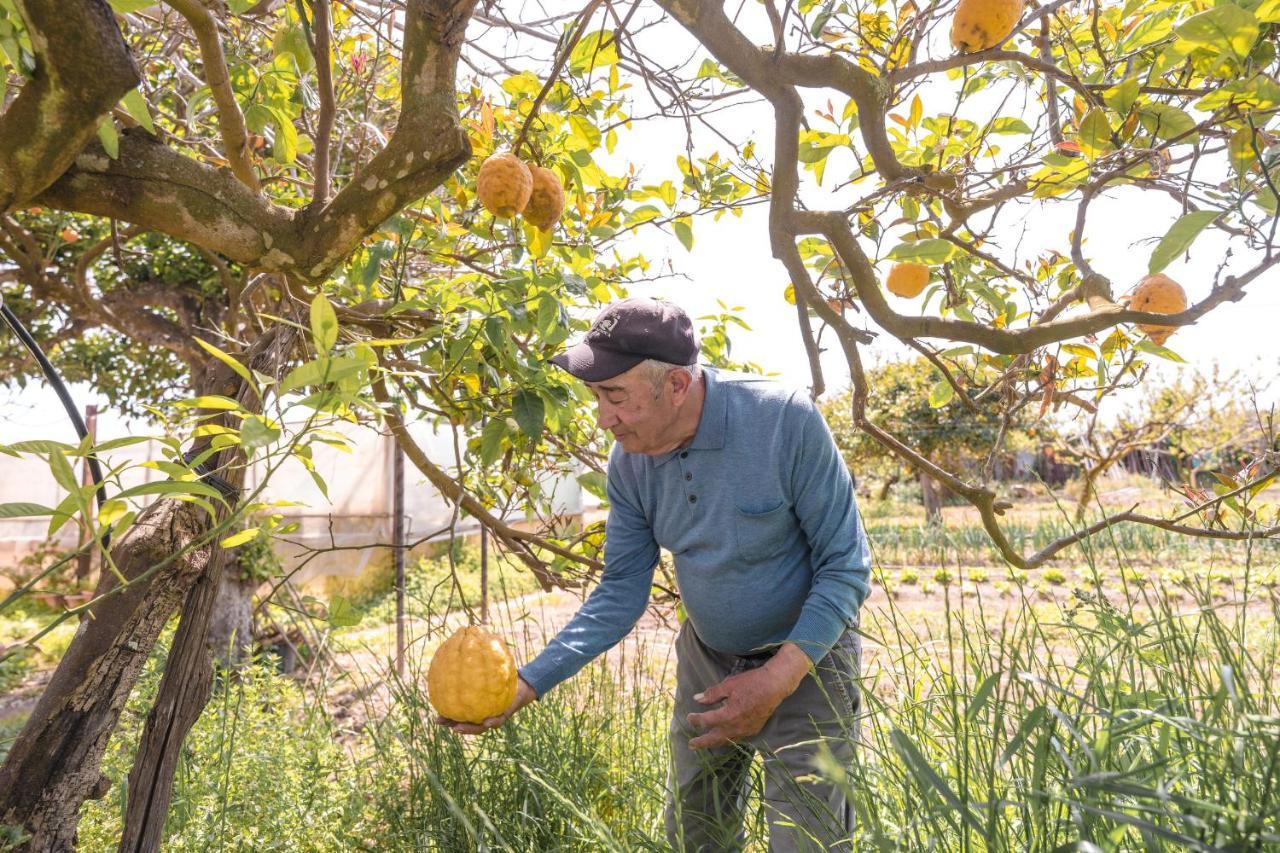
top-left (5, 468), bottom-right (1280, 850)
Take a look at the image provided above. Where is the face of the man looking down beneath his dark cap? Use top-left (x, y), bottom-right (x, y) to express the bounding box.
top-left (586, 365), bottom-right (689, 453)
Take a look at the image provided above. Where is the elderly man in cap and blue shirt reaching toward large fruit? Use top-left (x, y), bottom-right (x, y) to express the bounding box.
top-left (440, 298), bottom-right (870, 850)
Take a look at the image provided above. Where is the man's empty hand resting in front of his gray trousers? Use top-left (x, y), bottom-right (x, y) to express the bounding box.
top-left (689, 643), bottom-right (809, 749)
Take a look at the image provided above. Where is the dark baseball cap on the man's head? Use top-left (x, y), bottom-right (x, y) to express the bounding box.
top-left (550, 296), bottom-right (698, 382)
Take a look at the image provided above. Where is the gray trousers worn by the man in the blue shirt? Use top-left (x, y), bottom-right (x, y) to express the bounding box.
top-left (666, 620), bottom-right (861, 853)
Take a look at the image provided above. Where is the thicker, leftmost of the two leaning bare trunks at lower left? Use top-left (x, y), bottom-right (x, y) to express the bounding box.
top-left (0, 500), bottom-right (210, 850)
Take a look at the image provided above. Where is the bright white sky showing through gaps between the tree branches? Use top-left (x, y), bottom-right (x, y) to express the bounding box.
top-left (0, 4), bottom-right (1280, 442)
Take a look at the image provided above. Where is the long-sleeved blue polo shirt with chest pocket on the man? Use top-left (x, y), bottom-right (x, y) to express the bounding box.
top-left (520, 368), bottom-right (870, 697)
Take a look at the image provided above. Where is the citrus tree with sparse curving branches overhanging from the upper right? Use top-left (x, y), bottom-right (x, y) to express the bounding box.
top-left (660, 0), bottom-right (1280, 569)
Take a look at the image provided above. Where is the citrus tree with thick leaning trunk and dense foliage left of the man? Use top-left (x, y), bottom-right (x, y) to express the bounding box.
top-left (0, 0), bottom-right (739, 849)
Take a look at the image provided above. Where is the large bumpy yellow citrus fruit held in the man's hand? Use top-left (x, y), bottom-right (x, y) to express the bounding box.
top-left (426, 626), bottom-right (516, 722)
